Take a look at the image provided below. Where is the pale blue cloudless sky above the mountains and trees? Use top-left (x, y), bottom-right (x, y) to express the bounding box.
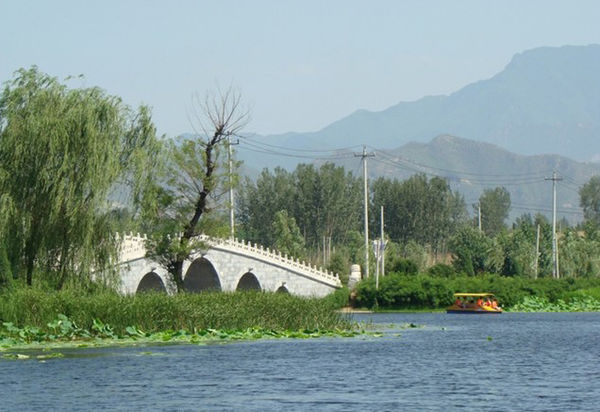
top-left (0, 0), bottom-right (600, 136)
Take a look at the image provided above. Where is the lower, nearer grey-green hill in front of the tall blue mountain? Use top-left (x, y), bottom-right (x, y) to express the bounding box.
top-left (318, 135), bottom-right (600, 222)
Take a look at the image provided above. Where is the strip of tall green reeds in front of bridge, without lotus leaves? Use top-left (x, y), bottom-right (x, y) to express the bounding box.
top-left (0, 288), bottom-right (350, 333)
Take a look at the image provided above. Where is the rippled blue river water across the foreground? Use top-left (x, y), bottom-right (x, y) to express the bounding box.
top-left (0, 313), bottom-right (600, 411)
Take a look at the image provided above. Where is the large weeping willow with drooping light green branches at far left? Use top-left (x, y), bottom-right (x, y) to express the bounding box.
top-left (0, 67), bottom-right (158, 288)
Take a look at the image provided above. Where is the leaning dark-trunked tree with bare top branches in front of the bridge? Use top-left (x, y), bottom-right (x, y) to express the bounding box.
top-left (146, 89), bottom-right (248, 292)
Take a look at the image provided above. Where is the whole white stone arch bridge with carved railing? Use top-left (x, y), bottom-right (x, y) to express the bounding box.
top-left (119, 234), bottom-right (342, 297)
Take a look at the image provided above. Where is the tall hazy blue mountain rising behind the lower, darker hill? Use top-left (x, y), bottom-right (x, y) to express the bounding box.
top-left (252, 45), bottom-right (600, 161)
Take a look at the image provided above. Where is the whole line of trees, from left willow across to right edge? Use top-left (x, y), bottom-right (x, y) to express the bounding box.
top-left (0, 67), bottom-right (600, 290)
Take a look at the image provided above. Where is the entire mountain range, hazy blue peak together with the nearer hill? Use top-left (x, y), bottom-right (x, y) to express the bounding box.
top-left (232, 45), bottom-right (600, 220)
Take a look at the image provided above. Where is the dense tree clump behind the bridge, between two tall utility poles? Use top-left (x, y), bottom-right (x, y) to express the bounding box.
top-left (238, 163), bottom-right (362, 254)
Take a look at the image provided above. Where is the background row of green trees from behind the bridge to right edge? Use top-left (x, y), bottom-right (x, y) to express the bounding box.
top-left (238, 164), bottom-right (600, 284)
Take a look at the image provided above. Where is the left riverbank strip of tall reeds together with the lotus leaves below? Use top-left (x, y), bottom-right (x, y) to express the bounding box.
top-left (0, 288), bottom-right (363, 356)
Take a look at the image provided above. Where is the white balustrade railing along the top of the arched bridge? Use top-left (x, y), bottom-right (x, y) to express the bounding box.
top-left (117, 233), bottom-right (342, 287)
